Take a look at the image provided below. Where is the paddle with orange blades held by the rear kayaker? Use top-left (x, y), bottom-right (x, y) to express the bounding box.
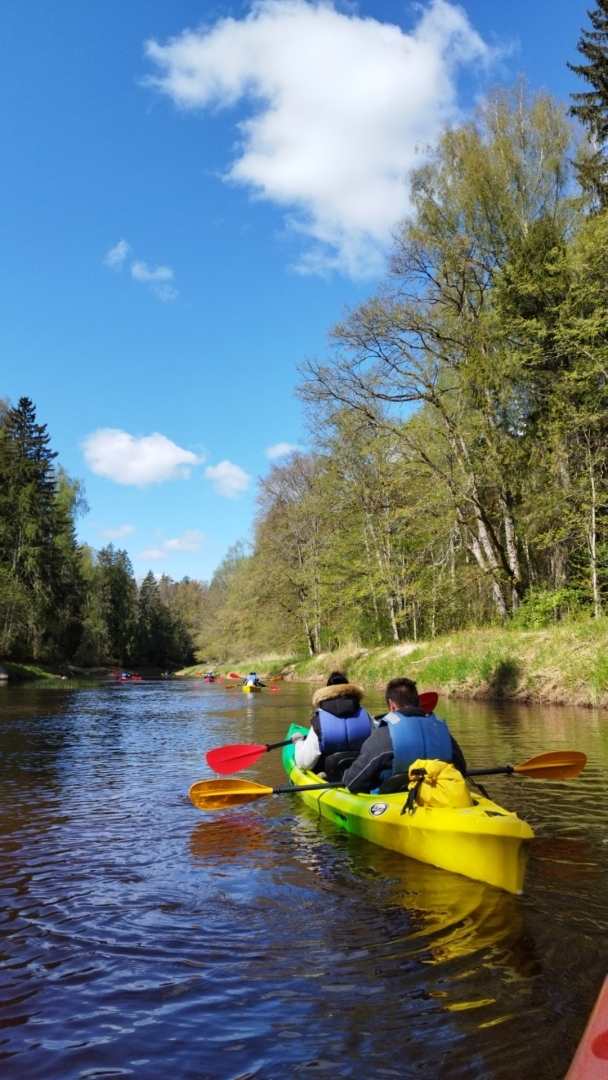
top-left (188, 743), bottom-right (586, 810)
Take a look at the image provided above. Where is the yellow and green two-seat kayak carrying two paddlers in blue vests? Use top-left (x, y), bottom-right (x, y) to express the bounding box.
top-left (283, 724), bottom-right (535, 893)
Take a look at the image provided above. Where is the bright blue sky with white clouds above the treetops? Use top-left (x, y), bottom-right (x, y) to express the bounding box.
top-left (0, 0), bottom-right (589, 578)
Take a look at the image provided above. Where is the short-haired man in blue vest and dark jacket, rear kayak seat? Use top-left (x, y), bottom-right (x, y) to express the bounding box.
top-left (342, 678), bottom-right (467, 794)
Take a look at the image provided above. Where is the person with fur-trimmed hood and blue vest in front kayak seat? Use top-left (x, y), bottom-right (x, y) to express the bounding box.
top-left (292, 672), bottom-right (373, 773)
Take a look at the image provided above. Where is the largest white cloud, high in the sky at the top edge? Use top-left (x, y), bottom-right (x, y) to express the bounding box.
top-left (146, 0), bottom-right (496, 278)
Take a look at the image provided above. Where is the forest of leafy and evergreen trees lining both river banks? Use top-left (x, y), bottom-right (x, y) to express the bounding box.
top-left (0, 3), bottom-right (608, 665)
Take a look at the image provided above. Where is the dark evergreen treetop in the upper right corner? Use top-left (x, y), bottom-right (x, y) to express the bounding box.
top-left (568, 0), bottom-right (608, 207)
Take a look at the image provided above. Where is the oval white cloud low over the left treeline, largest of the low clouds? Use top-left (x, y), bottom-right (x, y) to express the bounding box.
top-left (82, 428), bottom-right (200, 487)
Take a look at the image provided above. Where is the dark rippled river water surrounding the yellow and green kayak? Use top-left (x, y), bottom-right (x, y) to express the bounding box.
top-left (0, 679), bottom-right (608, 1080)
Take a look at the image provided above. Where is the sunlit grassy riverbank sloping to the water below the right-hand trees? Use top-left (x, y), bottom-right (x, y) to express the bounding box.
top-left (178, 618), bottom-right (608, 708)
